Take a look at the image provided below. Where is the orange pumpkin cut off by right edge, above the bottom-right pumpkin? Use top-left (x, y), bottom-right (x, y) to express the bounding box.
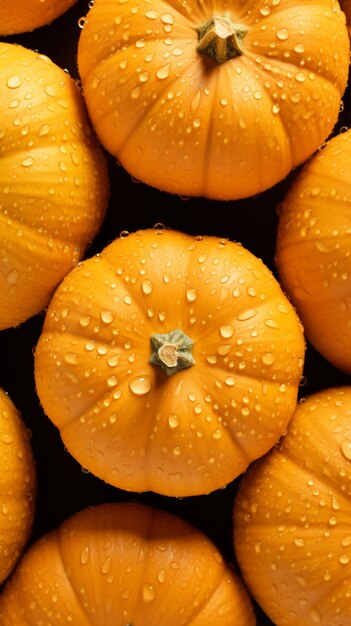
top-left (276, 126), bottom-right (351, 373)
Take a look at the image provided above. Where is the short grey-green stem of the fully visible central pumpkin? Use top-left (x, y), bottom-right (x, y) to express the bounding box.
top-left (150, 330), bottom-right (195, 376)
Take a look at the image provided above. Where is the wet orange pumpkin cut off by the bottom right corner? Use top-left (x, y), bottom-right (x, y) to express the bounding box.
top-left (234, 386), bottom-right (351, 626)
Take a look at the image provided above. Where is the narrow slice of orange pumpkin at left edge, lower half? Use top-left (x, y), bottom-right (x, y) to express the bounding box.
top-left (0, 389), bottom-right (36, 583)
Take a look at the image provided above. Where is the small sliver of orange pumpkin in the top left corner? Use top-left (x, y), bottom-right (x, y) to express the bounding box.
top-left (0, 0), bottom-right (77, 36)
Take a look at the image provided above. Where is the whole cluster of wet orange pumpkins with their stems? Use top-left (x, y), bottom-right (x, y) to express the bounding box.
top-left (0, 0), bottom-right (351, 626)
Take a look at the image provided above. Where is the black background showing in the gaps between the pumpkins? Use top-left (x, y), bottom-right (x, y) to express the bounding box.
top-left (0, 0), bottom-right (350, 626)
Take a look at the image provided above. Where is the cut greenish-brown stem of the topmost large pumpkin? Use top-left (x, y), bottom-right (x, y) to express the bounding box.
top-left (196, 15), bottom-right (247, 63)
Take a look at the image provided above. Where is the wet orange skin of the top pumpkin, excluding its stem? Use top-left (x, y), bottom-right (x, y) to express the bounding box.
top-left (78, 0), bottom-right (349, 200)
